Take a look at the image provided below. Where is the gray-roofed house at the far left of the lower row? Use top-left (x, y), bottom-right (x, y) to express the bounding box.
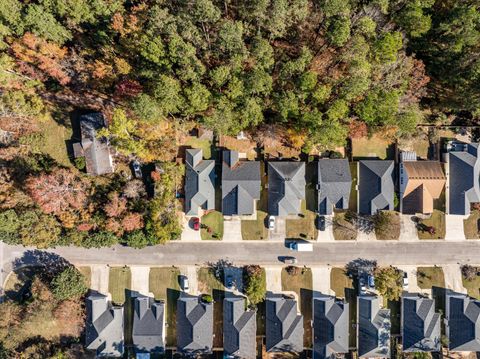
top-left (85, 293), bottom-right (124, 357)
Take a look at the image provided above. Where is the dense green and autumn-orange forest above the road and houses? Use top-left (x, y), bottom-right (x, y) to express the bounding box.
top-left (0, 0), bottom-right (480, 247)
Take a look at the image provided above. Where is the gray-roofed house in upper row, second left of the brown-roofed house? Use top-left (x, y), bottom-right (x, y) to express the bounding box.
top-left (317, 158), bottom-right (352, 215)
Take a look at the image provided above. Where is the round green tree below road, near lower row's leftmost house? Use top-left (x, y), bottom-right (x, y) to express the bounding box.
top-left (52, 266), bottom-right (88, 300)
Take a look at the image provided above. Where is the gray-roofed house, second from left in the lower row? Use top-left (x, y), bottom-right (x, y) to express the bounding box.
top-left (132, 295), bottom-right (165, 354)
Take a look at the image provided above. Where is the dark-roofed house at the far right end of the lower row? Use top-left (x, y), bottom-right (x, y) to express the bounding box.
top-left (445, 291), bottom-right (480, 352)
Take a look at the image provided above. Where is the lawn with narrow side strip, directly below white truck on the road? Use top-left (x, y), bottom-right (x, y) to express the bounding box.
top-left (282, 268), bottom-right (313, 348)
